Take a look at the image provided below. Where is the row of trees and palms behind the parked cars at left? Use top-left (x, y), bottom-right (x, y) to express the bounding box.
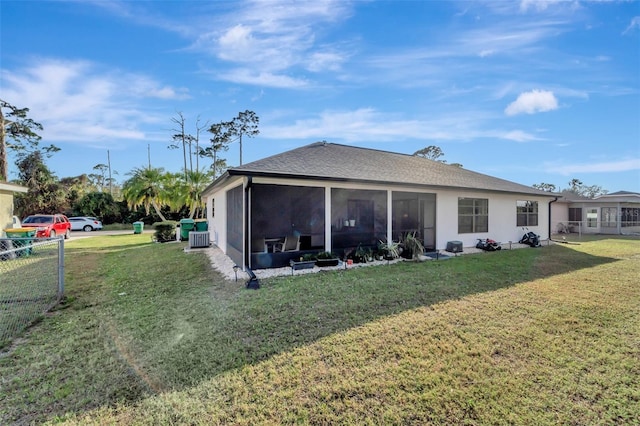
top-left (0, 100), bottom-right (259, 224)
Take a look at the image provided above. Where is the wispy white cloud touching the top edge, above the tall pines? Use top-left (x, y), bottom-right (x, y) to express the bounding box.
top-left (193, 0), bottom-right (351, 81)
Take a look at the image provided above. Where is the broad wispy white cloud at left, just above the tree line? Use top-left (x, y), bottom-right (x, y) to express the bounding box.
top-left (2, 58), bottom-right (186, 145)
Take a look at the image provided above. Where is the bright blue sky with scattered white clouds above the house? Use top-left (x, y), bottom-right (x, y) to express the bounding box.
top-left (0, 0), bottom-right (640, 192)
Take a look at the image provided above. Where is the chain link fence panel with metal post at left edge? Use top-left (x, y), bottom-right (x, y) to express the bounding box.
top-left (0, 238), bottom-right (64, 348)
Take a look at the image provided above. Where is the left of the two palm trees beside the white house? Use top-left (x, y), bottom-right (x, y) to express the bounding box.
top-left (122, 167), bottom-right (170, 221)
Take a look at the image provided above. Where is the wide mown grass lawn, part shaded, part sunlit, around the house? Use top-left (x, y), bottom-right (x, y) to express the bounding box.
top-left (0, 234), bottom-right (640, 424)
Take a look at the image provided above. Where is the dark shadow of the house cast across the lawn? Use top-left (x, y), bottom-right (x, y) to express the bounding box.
top-left (0, 241), bottom-right (618, 422)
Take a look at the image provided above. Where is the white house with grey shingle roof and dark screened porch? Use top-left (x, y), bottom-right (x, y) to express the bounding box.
top-left (203, 142), bottom-right (555, 269)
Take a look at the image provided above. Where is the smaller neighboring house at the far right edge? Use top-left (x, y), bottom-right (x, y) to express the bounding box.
top-left (551, 191), bottom-right (640, 235)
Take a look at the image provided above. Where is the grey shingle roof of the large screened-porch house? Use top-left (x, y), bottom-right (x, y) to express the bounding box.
top-left (228, 142), bottom-right (554, 197)
